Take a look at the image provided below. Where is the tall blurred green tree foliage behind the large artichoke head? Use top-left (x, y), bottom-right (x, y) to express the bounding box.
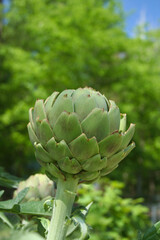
top-left (0, 0), bottom-right (160, 200)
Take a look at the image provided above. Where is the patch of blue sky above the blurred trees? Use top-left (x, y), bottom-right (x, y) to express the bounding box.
top-left (121, 0), bottom-right (160, 36)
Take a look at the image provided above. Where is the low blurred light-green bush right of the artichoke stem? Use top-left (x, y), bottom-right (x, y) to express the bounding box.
top-left (78, 179), bottom-right (149, 240)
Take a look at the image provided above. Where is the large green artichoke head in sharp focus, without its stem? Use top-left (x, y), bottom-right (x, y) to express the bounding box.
top-left (28, 87), bottom-right (135, 182)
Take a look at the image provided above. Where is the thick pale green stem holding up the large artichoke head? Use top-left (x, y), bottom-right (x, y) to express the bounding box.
top-left (47, 177), bottom-right (78, 240)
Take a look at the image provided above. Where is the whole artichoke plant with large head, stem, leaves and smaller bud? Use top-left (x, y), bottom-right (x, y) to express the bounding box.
top-left (0, 87), bottom-right (160, 240)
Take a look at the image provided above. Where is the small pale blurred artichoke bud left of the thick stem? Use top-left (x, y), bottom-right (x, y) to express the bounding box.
top-left (13, 174), bottom-right (55, 202)
